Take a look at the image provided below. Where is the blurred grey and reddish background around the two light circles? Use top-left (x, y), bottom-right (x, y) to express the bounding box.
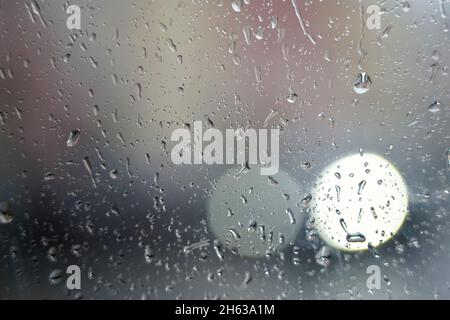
top-left (0, 0), bottom-right (450, 299)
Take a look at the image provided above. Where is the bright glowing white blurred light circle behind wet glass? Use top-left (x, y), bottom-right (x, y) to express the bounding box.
top-left (310, 153), bottom-right (408, 251)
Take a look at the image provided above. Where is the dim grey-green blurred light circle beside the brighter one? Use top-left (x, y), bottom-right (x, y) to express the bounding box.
top-left (208, 166), bottom-right (304, 257)
